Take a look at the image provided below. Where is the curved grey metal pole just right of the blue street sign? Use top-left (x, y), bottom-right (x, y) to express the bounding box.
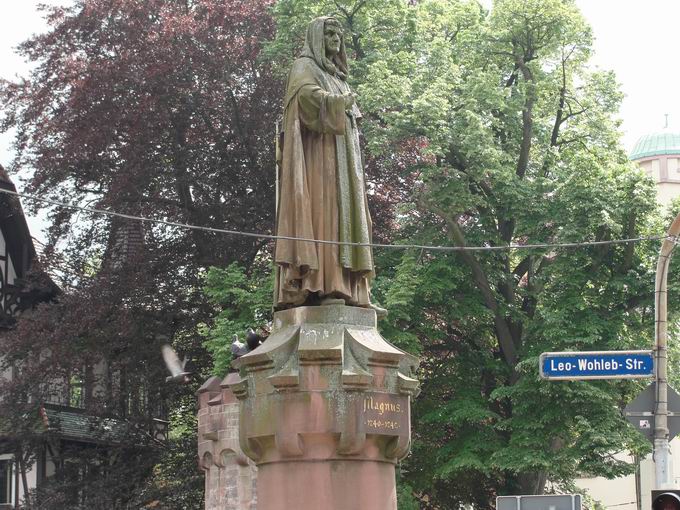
top-left (654, 214), bottom-right (680, 489)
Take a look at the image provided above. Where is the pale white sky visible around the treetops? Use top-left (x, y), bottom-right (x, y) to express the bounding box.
top-left (0, 0), bottom-right (680, 237)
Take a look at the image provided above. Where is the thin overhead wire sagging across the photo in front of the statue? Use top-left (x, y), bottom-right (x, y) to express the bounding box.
top-left (0, 188), bottom-right (668, 252)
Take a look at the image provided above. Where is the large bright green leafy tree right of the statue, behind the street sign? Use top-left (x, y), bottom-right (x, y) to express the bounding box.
top-left (267, 0), bottom-right (661, 508)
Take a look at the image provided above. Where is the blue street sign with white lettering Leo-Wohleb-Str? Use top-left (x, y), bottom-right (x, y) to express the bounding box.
top-left (539, 351), bottom-right (654, 380)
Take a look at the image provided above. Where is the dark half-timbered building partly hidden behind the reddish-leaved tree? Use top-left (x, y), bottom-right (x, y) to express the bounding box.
top-left (0, 166), bottom-right (167, 510)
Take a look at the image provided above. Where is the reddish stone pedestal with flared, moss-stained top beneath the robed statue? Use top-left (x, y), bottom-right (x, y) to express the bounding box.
top-left (230, 305), bottom-right (418, 510)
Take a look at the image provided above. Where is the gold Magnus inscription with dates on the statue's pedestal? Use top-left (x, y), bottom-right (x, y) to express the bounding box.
top-left (359, 393), bottom-right (410, 436)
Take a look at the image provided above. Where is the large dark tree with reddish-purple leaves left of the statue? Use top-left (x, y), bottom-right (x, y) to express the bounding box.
top-left (0, 0), bottom-right (283, 509)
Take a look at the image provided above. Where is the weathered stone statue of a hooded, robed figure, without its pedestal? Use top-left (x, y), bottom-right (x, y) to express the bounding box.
top-left (275, 17), bottom-right (385, 315)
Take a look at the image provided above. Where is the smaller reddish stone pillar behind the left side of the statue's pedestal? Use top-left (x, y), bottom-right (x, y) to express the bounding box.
top-left (198, 374), bottom-right (257, 510)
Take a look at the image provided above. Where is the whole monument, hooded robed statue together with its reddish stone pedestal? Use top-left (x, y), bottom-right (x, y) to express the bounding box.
top-left (231, 22), bottom-right (419, 502)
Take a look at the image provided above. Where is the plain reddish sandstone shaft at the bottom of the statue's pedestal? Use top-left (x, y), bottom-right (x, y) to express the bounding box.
top-left (257, 460), bottom-right (397, 510)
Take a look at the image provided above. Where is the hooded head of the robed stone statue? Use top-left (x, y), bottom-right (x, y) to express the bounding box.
top-left (302, 16), bottom-right (347, 80)
